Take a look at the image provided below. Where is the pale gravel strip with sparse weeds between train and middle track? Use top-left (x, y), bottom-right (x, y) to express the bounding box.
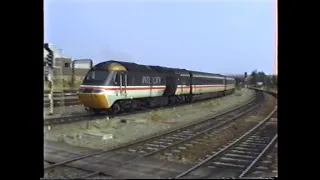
top-left (44, 89), bottom-right (254, 149)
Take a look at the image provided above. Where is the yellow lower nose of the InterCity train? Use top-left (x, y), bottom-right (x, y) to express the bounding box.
top-left (77, 88), bottom-right (110, 109)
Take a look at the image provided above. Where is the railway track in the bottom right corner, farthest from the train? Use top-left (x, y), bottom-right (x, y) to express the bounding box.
top-left (174, 109), bottom-right (278, 179)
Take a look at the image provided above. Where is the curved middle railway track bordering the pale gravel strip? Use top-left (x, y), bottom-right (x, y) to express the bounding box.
top-left (44, 92), bottom-right (264, 178)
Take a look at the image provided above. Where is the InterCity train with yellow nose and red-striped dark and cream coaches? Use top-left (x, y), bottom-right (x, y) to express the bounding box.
top-left (77, 60), bottom-right (235, 113)
